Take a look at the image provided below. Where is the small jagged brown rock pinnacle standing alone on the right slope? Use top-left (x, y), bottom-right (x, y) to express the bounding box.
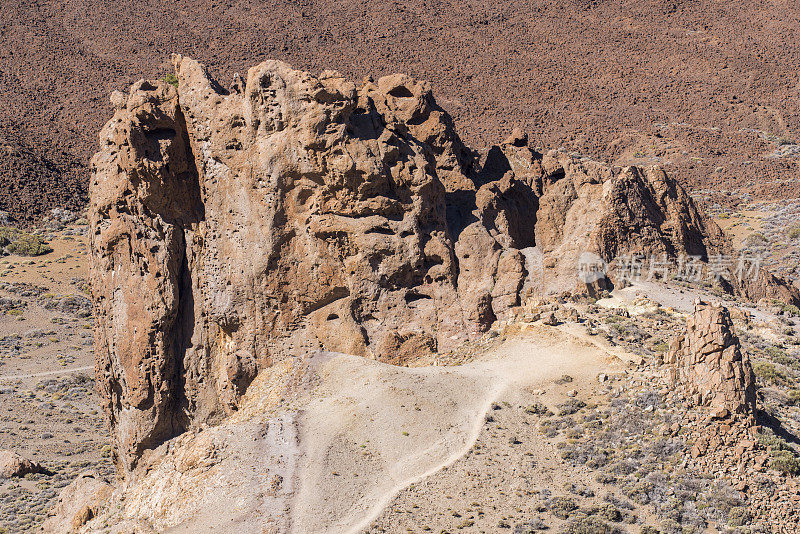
top-left (666, 301), bottom-right (756, 414)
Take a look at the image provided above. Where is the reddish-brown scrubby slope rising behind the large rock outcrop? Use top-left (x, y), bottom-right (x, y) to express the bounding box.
top-left (0, 0), bottom-right (800, 224)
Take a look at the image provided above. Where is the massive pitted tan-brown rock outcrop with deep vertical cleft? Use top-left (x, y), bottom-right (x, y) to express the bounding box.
top-left (90, 56), bottom-right (794, 473)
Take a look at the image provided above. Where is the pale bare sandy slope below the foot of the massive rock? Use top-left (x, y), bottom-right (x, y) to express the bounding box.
top-left (111, 324), bottom-right (627, 534)
